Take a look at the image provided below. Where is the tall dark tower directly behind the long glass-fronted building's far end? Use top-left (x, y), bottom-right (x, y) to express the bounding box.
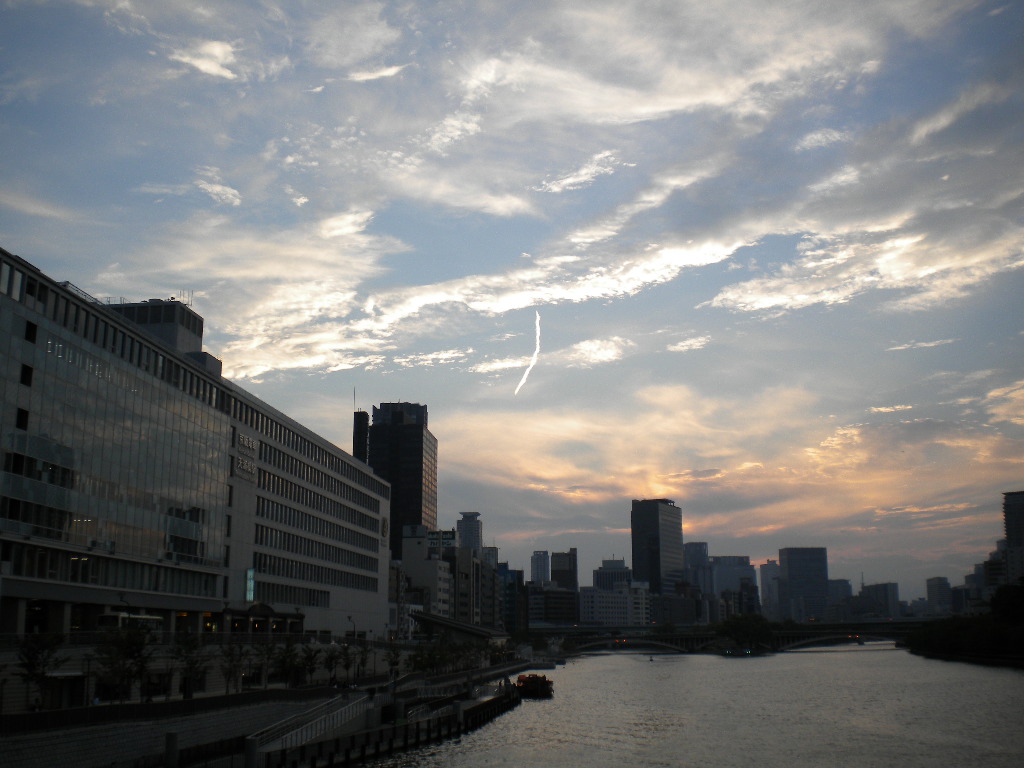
top-left (367, 402), bottom-right (437, 560)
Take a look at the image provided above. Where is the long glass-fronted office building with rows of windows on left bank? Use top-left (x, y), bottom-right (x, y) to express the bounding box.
top-left (0, 249), bottom-right (390, 636)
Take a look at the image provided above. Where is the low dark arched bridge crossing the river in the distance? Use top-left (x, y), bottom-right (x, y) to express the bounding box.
top-left (543, 621), bottom-right (925, 653)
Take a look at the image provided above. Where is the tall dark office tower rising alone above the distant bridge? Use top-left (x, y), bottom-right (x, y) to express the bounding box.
top-left (630, 499), bottom-right (683, 595)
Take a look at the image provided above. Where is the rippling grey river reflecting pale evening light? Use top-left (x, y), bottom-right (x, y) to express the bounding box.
top-left (369, 643), bottom-right (1024, 768)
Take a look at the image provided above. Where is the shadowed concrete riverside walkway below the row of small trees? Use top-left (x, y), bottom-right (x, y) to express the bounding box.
top-left (0, 698), bottom-right (324, 768)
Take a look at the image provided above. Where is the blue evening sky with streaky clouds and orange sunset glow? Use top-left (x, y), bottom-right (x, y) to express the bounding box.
top-left (0, 0), bottom-right (1024, 599)
